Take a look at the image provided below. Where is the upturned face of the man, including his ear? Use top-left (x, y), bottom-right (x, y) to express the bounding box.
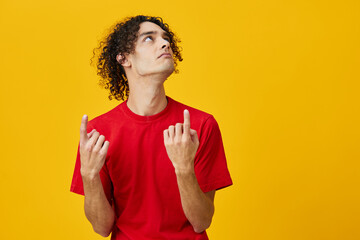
top-left (127, 22), bottom-right (175, 77)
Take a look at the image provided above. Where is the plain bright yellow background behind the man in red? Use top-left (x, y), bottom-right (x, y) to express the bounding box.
top-left (0, 0), bottom-right (360, 240)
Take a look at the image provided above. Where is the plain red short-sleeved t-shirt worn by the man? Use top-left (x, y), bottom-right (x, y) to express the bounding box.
top-left (70, 96), bottom-right (232, 240)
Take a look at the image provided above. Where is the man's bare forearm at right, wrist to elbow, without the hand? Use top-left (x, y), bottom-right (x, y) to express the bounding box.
top-left (175, 169), bottom-right (214, 233)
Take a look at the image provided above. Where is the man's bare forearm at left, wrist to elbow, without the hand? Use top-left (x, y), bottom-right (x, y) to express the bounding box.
top-left (82, 174), bottom-right (115, 237)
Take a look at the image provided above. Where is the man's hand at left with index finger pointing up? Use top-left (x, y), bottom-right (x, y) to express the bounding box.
top-left (80, 115), bottom-right (109, 177)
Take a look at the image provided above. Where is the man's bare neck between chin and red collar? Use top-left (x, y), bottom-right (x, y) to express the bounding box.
top-left (127, 75), bottom-right (167, 116)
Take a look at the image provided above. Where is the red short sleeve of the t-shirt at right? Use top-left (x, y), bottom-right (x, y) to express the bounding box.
top-left (194, 115), bottom-right (233, 192)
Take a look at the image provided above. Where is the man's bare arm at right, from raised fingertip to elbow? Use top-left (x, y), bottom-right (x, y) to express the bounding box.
top-left (164, 110), bottom-right (215, 233)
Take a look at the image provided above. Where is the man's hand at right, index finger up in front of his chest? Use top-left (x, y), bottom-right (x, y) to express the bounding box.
top-left (164, 109), bottom-right (199, 171)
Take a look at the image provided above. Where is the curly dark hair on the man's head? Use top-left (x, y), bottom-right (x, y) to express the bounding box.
top-left (91, 15), bottom-right (183, 101)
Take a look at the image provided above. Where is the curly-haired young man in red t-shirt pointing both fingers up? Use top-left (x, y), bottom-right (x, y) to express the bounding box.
top-left (71, 16), bottom-right (232, 240)
